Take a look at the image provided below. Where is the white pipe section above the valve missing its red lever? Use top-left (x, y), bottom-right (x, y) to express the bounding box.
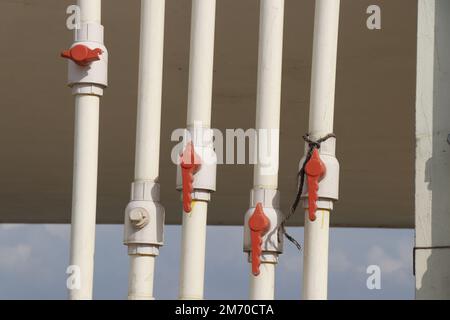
top-left (134, 0), bottom-right (165, 181)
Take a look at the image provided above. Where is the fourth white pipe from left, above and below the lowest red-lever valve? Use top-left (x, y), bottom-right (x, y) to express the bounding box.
top-left (250, 0), bottom-right (284, 300)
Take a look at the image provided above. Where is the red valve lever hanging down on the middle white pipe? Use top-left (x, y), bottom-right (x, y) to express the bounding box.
top-left (181, 142), bottom-right (201, 213)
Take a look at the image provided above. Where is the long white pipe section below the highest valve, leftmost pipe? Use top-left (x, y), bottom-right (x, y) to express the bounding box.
top-left (69, 95), bottom-right (100, 299)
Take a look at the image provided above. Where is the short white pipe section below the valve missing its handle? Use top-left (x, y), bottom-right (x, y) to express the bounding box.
top-left (128, 255), bottom-right (156, 300)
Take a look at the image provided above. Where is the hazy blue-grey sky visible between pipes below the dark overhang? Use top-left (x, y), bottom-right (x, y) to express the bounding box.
top-left (0, 224), bottom-right (414, 300)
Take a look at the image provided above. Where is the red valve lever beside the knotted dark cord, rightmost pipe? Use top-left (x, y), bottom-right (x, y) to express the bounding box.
top-left (305, 149), bottom-right (326, 221)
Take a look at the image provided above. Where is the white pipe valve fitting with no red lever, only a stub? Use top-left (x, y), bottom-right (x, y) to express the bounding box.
top-left (124, 181), bottom-right (165, 255)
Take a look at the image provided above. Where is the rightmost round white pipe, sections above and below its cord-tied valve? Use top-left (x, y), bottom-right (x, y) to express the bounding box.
top-left (303, 0), bottom-right (340, 300)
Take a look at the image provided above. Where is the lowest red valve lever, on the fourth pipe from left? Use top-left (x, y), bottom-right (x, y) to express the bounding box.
top-left (248, 202), bottom-right (270, 276)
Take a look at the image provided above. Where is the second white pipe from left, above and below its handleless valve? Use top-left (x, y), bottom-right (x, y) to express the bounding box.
top-left (128, 0), bottom-right (165, 300)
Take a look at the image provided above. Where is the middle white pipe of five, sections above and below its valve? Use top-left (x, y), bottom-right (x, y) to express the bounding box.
top-left (179, 0), bottom-right (216, 299)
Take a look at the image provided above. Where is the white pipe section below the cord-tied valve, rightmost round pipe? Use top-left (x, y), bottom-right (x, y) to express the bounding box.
top-left (303, 210), bottom-right (330, 300)
